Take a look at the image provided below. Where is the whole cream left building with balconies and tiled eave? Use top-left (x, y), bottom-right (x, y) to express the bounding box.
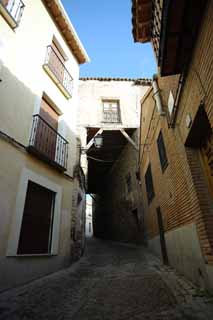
top-left (0, 0), bottom-right (89, 290)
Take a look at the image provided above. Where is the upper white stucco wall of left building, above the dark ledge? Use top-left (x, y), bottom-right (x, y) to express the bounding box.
top-left (0, 0), bottom-right (79, 173)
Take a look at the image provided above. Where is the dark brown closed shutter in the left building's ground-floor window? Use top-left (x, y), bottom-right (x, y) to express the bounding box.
top-left (18, 181), bottom-right (55, 254)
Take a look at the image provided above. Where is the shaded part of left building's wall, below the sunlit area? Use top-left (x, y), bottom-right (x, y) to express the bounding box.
top-left (0, 66), bottom-right (80, 291)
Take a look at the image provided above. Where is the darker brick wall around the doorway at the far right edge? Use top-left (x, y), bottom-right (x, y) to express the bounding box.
top-left (177, 1), bottom-right (213, 264)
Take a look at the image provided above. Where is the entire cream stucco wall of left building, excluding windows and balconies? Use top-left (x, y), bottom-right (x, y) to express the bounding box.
top-left (0, 0), bottom-right (88, 291)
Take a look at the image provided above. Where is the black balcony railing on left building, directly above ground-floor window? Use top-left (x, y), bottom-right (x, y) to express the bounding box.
top-left (28, 114), bottom-right (68, 171)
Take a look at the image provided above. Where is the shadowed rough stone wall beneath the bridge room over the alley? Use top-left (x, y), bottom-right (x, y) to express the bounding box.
top-left (93, 130), bottom-right (144, 243)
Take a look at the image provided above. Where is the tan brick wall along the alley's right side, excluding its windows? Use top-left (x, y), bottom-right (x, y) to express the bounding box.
top-left (140, 1), bottom-right (213, 282)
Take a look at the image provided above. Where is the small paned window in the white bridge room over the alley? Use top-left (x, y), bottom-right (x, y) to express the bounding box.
top-left (103, 100), bottom-right (121, 123)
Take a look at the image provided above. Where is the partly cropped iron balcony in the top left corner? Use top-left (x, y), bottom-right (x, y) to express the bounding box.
top-left (0, 0), bottom-right (25, 28)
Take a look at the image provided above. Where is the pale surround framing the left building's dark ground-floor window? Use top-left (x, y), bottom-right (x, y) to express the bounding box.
top-left (6, 168), bottom-right (62, 257)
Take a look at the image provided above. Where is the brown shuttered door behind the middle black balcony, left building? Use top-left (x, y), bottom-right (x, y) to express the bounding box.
top-left (35, 99), bottom-right (59, 161)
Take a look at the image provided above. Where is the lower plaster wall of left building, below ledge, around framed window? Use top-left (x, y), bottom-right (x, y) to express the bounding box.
top-left (0, 140), bottom-right (74, 291)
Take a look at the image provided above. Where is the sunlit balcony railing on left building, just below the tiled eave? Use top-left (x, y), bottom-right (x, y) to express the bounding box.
top-left (44, 46), bottom-right (73, 98)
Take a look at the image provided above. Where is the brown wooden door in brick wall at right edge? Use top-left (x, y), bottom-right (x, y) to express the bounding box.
top-left (200, 129), bottom-right (213, 197)
